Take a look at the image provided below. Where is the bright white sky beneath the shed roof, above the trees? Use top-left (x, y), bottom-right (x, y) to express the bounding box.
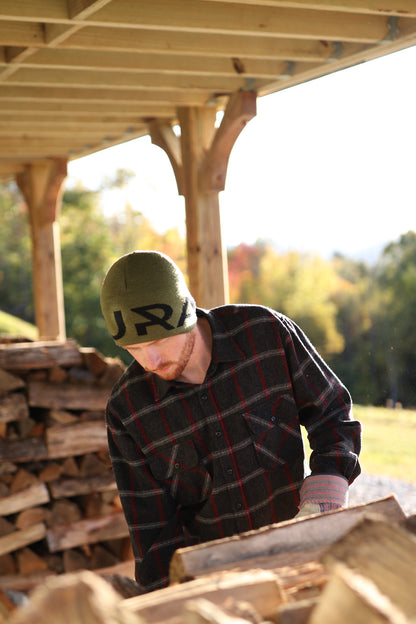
top-left (67, 47), bottom-right (416, 261)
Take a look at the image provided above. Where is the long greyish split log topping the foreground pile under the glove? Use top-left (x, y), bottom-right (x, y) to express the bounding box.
top-left (170, 496), bottom-right (406, 583)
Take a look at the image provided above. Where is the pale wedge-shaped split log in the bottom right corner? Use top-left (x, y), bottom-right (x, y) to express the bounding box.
top-left (308, 566), bottom-right (414, 624)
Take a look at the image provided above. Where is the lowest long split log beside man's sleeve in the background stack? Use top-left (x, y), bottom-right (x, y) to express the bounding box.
top-left (46, 512), bottom-right (129, 552)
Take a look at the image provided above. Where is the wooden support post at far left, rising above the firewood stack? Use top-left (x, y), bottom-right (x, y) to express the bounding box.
top-left (16, 158), bottom-right (67, 341)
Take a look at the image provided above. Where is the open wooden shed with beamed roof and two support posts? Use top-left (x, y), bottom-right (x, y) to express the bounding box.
top-left (0, 0), bottom-right (416, 340)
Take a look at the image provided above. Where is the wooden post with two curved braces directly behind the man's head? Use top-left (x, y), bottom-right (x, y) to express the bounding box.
top-left (150, 91), bottom-right (256, 308)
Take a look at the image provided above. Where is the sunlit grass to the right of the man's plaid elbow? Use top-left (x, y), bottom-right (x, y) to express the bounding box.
top-left (354, 405), bottom-right (416, 483)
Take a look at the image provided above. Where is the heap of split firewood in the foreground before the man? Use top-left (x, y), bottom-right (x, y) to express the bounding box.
top-left (5, 496), bottom-right (416, 624)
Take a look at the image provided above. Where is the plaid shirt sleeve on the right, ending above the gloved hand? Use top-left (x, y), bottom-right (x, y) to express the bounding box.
top-left (283, 318), bottom-right (361, 486)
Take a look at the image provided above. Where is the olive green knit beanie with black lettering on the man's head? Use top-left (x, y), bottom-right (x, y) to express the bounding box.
top-left (101, 251), bottom-right (197, 347)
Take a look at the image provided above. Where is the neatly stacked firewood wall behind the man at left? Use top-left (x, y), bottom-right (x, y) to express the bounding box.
top-left (0, 340), bottom-right (133, 591)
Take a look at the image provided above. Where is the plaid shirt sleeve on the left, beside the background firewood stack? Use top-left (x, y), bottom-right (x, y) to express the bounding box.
top-left (107, 407), bottom-right (184, 591)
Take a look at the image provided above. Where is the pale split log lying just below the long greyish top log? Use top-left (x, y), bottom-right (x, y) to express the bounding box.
top-left (124, 570), bottom-right (285, 624)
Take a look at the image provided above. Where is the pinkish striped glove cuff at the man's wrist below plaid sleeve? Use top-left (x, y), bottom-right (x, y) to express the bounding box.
top-left (299, 474), bottom-right (348, 511)
